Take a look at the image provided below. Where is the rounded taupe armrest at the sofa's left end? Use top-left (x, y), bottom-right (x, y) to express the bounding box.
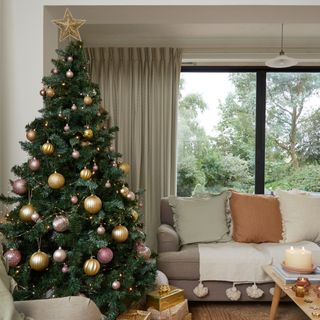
top-left (157, 224), bottom-right (180, 253)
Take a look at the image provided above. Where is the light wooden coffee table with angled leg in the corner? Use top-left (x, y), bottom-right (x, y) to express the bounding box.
top-left (263, 266), bottom-right (320, 320)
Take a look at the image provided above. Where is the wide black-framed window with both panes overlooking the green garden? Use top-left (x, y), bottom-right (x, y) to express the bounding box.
top-left (177, 69), bottom-right (320, 196)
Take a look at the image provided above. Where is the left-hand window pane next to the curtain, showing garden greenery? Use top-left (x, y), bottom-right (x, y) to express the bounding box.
top-left (177, 72), bottom-right (256, 196)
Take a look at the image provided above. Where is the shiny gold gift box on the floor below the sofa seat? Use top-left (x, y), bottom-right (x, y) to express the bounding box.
top-left (147, 286), bottom-right (185, 311)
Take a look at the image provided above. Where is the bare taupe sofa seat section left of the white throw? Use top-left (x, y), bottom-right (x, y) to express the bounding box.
top-left (157, 244), bottom-right (200, 280)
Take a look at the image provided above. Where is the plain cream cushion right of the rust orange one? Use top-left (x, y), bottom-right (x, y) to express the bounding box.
top-left (276, 190), bottom-right (320, 242)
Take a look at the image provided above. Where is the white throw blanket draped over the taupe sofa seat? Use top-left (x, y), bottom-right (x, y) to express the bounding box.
top-left (199, 241), bottom-right (320, 283)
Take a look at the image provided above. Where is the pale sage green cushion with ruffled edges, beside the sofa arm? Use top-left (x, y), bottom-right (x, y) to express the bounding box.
top-left (168, 192), bottom-right (230, 245)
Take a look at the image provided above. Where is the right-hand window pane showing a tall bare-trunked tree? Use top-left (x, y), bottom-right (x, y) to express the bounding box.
top-left (265, 72), bottom-right (320, 191)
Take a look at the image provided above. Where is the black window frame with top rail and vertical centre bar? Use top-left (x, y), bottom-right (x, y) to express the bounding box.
top-left (181, 66), bottom-right (320, 194)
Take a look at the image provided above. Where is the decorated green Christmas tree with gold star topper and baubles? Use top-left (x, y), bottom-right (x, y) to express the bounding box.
top-left (0, 11), bottom-right (156, 319)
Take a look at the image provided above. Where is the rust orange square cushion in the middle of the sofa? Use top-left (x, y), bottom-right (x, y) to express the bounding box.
top-left (230, 191), bottom-right (282, 243)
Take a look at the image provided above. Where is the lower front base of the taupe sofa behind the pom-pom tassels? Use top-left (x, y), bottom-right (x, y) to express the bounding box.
top-left (169, 279), bottom-right (274, 302)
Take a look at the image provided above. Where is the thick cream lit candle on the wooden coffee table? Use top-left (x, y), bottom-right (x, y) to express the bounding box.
top-left (284, 246), bottom-right (312, 270)
